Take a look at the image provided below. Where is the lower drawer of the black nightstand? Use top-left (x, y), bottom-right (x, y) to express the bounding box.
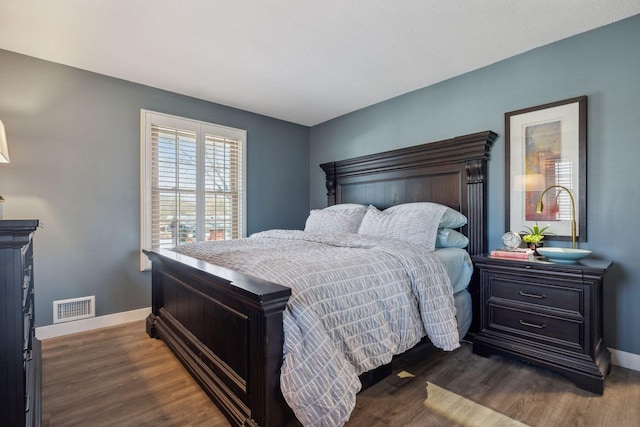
top-left (489, 305), bottom-right (584, 350)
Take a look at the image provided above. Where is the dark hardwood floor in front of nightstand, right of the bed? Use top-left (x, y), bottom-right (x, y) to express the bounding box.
top-left (347, 343), bottom-right (640, 427)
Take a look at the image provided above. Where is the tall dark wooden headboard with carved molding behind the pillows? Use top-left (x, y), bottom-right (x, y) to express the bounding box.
top-left (320, 131), bottom-right (497, 255)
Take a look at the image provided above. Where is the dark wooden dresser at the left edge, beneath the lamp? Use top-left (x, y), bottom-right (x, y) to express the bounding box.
top-left (0, 220), bottom-right (42, 426)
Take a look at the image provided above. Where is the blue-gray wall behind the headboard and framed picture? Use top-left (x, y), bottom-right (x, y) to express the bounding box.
top-left (310, 15), bottom-right (640, 354)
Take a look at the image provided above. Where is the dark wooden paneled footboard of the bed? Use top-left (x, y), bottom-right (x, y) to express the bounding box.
top-left (145, 250), bottom-right (293, 426)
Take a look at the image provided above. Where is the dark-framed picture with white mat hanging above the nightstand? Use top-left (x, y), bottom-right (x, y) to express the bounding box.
top-left (505, 96), bottom-right (587, 242)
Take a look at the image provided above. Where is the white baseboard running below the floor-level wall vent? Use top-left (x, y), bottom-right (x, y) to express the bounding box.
top-left (36, 307), bottom-right (151, 340)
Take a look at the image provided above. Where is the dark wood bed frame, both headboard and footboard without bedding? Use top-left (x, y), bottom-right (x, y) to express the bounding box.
top-left (144, 131), bottom-right (497, 427)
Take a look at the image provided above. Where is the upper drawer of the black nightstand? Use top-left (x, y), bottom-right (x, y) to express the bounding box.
top-left (489, 275), bottom-right (584, 316)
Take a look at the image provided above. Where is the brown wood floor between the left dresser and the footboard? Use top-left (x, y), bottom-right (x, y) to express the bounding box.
top-left (42, 322), bottom-right (229, 427)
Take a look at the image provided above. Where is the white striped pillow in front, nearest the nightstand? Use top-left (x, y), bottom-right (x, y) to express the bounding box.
top-left (358, 206), bottom-right (444, 250)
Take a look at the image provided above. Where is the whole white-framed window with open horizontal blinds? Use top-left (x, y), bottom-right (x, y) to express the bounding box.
top-left (141, 110), bottom-right (246, 270)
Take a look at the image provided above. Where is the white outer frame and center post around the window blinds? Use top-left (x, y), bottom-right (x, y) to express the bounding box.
top-left (140, 109), bottom-right (247, 271)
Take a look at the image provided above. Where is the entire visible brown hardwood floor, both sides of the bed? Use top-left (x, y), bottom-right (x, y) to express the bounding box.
top-left (42, 322), bottom-right (640, 427)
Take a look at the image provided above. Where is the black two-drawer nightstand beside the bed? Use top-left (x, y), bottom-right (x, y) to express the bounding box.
top-left (473, 256), bottom-right (612, 394)
